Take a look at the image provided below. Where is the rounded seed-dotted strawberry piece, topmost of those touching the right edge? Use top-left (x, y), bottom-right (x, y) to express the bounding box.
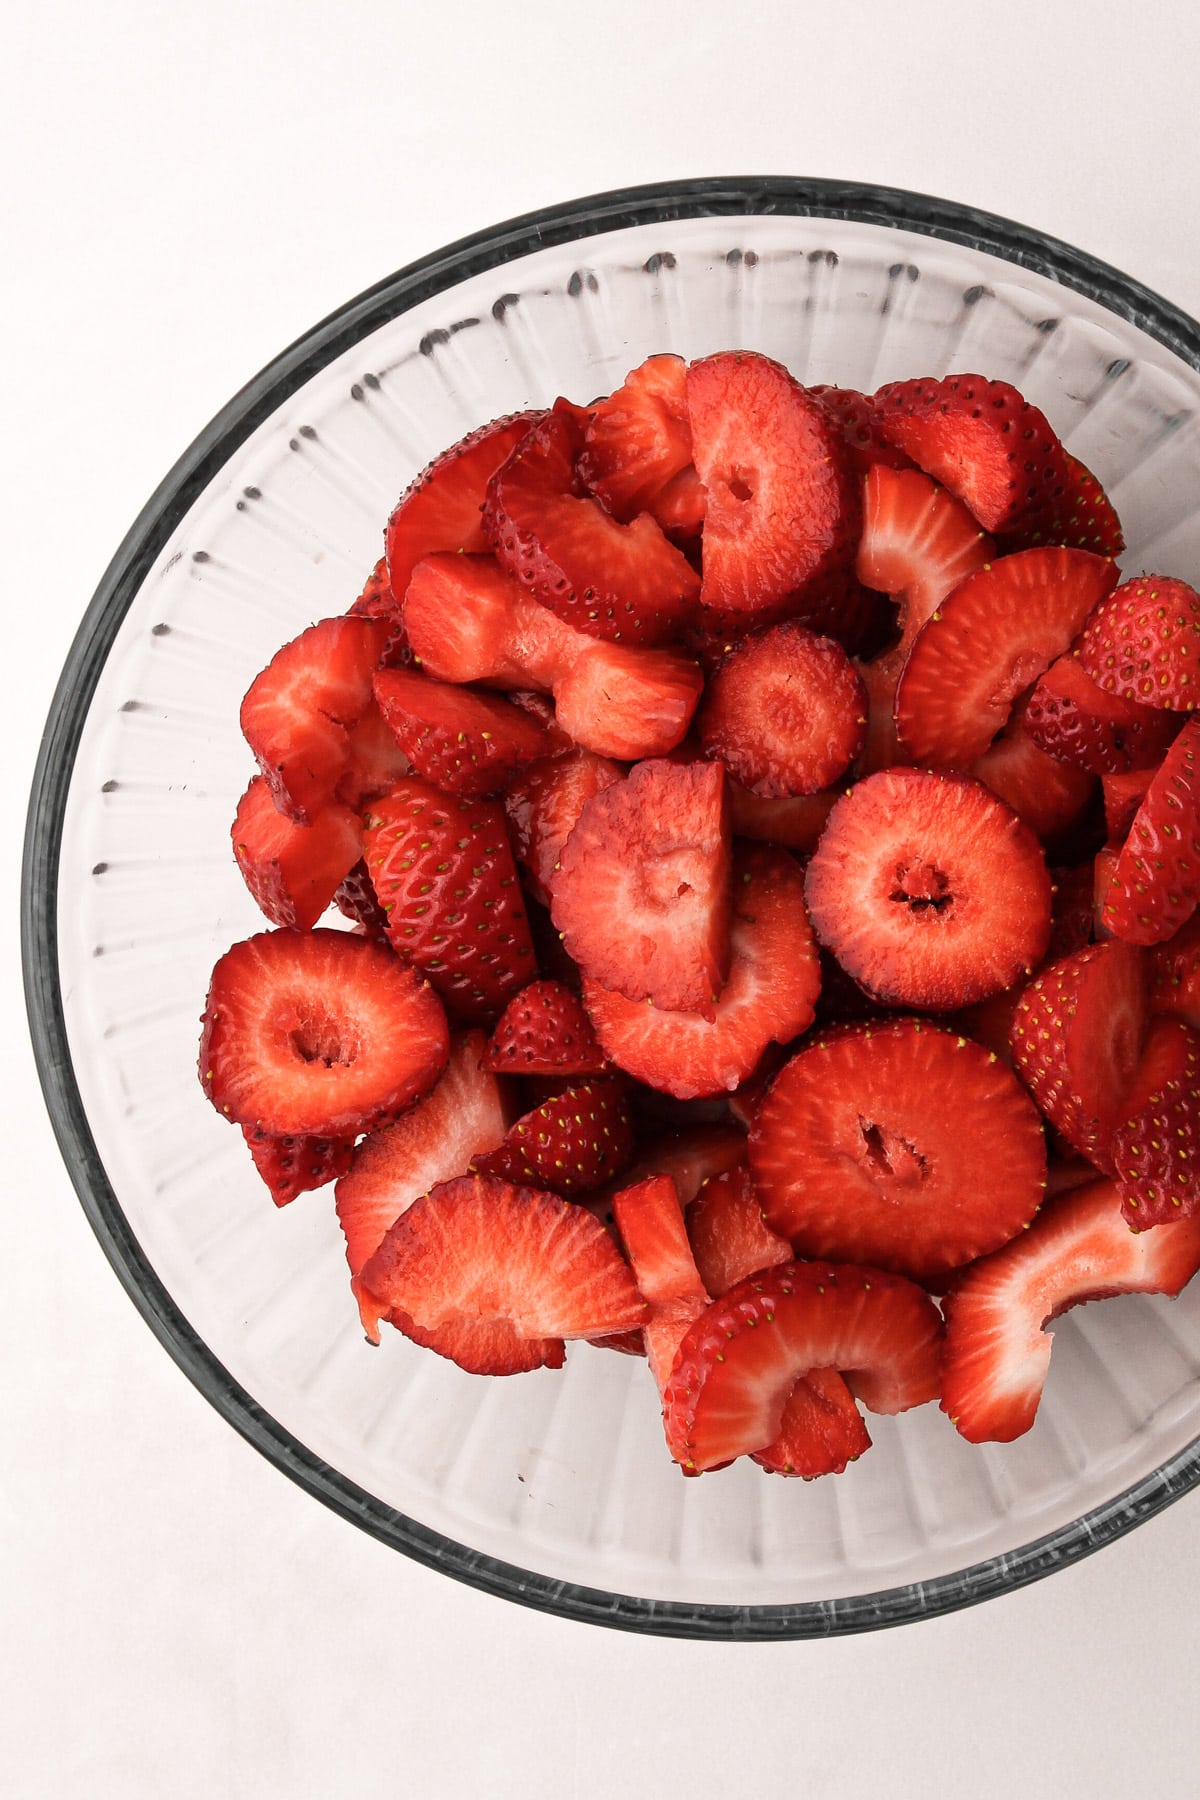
top-left (1079, 574), bottom-right (1200, 713)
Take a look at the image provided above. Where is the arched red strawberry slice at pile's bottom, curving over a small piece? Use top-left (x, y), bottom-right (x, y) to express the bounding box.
top-left (664, 1262), bottom-right (941, 1474)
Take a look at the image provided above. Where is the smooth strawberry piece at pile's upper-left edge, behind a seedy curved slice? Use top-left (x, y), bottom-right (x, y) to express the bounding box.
top-left (387, 412), bottom-right (542, 603)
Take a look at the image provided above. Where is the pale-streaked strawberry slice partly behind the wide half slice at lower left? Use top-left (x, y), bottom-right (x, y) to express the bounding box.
top-left (336, 1031), bottom-right (509, 1343)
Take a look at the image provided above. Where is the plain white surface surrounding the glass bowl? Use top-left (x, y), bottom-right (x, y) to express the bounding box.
top-left (9, 0), bottom-right (1200, 1800)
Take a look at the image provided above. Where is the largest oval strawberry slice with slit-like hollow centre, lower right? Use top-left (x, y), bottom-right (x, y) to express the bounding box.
top-left (748, 1019), bottom-right (1045, 1280)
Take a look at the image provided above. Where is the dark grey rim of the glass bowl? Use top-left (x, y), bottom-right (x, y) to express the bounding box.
top-left (22, 176), bottom-right (1200, 1642)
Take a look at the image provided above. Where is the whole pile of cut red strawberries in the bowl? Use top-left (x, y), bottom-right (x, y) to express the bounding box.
top-left (200, 353), bottom-right (1200, 1476)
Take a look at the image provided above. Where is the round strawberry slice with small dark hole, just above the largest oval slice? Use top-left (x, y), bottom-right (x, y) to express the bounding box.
top-left (806, 769), bottom-right (1051, 1008)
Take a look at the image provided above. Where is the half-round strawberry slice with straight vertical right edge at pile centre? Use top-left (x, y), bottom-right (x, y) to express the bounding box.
top-left (551, 761), bottom-right (730, 1019)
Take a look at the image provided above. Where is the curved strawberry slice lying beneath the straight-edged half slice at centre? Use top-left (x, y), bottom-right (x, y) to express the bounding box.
top-left (583, 846), bottom-right (820, 1100)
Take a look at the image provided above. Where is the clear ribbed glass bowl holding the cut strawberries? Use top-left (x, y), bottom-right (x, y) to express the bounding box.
top-left (25, 178), bottom-right (1200, 1638)
